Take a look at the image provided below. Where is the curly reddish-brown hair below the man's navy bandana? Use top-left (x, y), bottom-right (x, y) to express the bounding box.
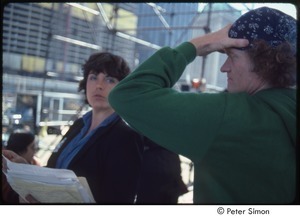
top-left (247, 40), bottom-right (297, 88)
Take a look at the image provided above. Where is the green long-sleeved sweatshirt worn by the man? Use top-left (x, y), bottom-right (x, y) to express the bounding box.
top-left (109, 42), bottom-right (296, 204)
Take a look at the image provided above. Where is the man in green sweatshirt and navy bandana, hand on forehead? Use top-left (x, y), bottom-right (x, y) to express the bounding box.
top-left (109, 7), bottom-right (297, 204)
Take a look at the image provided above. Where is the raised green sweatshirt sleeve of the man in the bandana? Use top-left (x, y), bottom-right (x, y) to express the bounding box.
top-left (109, 42), bottom-right (224, 160)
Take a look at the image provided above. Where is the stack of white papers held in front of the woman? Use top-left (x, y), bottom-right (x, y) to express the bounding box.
top-left (2, 155), bottom-right (95, 203)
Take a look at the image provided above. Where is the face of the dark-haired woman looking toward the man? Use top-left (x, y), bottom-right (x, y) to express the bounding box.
top-left (86, 71), bottom-right (119, 110)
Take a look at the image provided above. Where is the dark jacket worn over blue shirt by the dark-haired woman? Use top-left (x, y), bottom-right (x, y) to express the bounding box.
top-left (47, 118), bottom-right (143, 204)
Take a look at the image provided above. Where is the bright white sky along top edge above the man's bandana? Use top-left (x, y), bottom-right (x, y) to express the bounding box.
top-left (199, 3), bottom-right (297, 19)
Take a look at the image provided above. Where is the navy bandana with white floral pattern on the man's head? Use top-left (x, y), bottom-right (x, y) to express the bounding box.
top-left (228, 7), bottom-right (297, 52)
